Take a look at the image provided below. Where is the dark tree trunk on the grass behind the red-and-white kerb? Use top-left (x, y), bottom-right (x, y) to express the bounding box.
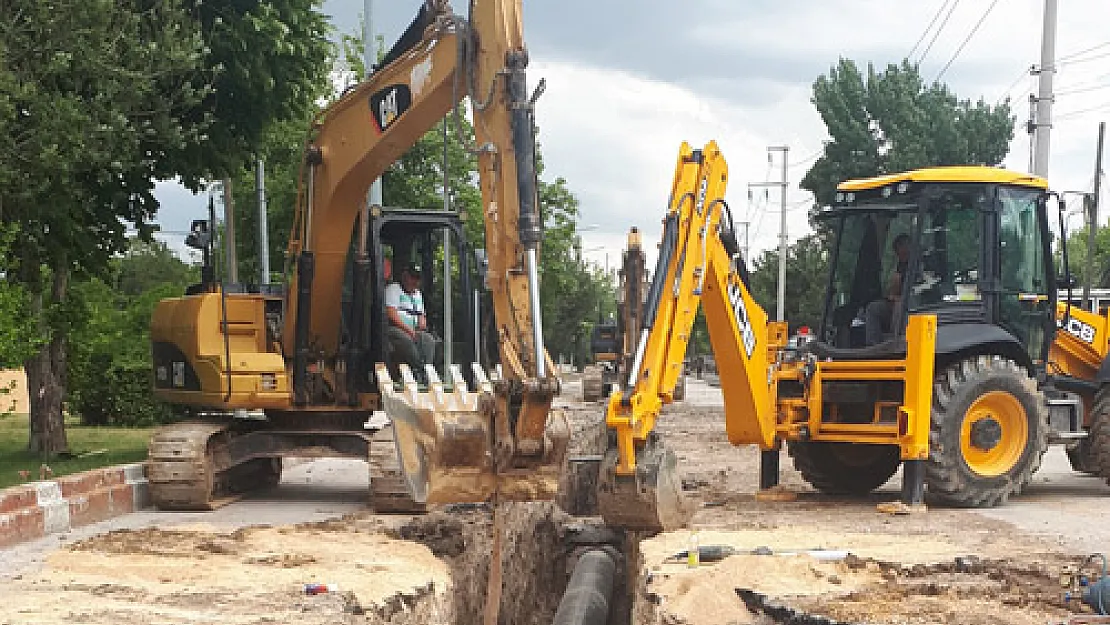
top-left (23, 263), bottom-right (69, 458)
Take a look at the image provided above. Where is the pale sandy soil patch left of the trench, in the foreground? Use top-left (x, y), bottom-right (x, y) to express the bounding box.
top-left (0, 521), bottom-right (454, 625)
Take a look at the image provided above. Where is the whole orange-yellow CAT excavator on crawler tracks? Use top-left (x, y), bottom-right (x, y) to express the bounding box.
top-left (148, 0), bottom-right (569, 510)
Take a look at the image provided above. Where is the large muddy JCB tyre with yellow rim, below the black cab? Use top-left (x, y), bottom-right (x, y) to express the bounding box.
top-left (925, 355), bottom-right (1048, 507)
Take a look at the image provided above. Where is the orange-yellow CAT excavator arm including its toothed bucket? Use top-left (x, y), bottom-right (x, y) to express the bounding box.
top-left (283, 0), bottom-right (568, 503)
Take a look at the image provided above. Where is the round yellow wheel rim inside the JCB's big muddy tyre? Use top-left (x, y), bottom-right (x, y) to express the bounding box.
top-left (960, 391), bottom-right (1029, 477)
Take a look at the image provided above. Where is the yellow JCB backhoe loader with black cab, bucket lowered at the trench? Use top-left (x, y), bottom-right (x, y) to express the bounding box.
top-left (598, 143), bottom-right (1087, 531)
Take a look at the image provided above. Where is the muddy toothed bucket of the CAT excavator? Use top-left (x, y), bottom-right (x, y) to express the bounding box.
top-left (376, 364), bottom-right (571, 504)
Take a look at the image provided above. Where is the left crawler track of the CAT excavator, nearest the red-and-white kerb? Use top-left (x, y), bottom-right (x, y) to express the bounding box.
top-left (147, 422), bottom-right (281, 511)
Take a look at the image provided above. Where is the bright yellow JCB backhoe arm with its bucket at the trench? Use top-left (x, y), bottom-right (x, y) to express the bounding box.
top-left (598, 142), bottom-right (783, 531)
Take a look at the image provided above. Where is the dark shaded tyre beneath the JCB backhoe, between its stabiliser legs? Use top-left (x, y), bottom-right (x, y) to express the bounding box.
top-left (787, 442), bottom-right (901, 495)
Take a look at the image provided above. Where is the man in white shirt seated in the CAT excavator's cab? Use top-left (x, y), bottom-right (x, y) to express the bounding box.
top-left (385, 265), bottom-right (435, 382)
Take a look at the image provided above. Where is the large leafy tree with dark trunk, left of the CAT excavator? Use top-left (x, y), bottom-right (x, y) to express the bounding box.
top-left (0, 0), bottom-right (327, 455)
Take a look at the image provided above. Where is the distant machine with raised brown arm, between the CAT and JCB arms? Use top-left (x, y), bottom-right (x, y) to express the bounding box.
top-left (582, 226), bottom-right (686, 402)
